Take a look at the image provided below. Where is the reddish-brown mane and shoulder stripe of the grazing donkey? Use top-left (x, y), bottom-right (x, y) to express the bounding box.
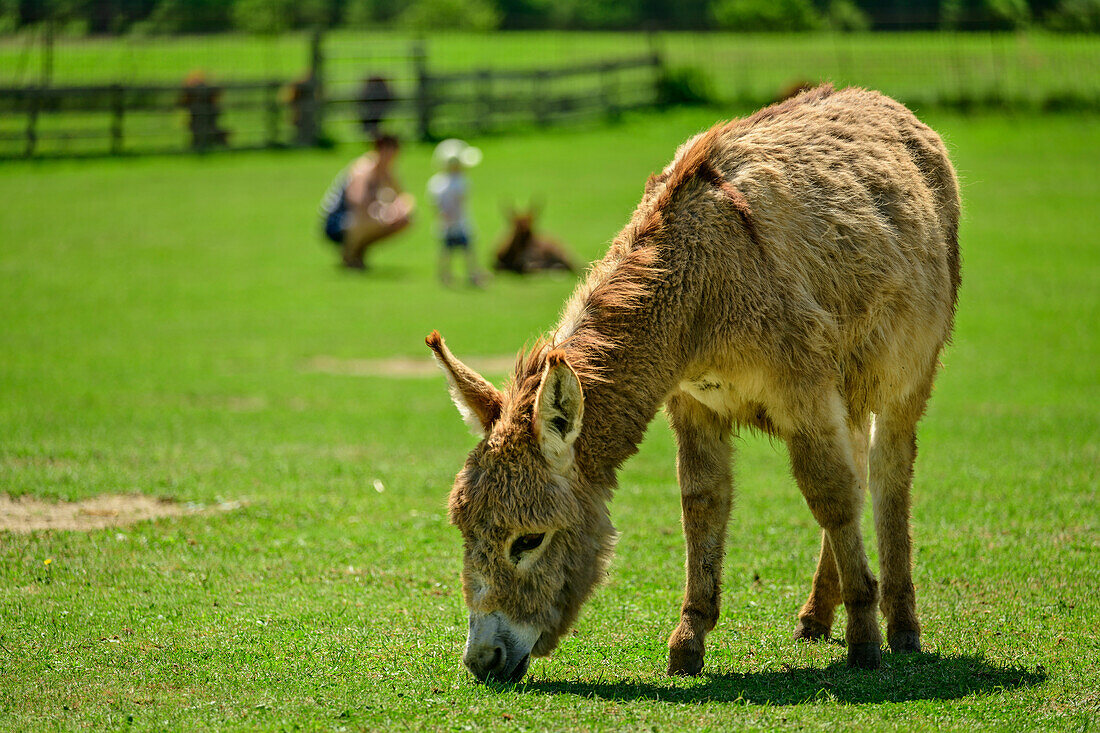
top-left (507, 84), bottom-right (834, 414)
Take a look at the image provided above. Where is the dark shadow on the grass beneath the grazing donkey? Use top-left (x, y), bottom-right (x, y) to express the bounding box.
top-left (523, 654), bottom-right (1046, 705)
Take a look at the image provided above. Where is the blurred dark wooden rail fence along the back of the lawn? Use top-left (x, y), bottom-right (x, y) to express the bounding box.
top-left (0, 36), bottom-right (661, 158)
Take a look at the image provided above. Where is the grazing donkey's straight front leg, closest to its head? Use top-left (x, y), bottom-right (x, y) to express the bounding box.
top-left (668, 393), bottom-right (733, 675)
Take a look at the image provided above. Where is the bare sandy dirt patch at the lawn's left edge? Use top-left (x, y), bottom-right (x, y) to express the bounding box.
top-left (0, 494), bottom-right (240, 534)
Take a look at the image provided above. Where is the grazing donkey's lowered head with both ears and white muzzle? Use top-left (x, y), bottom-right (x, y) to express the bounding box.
top-left (427, 332), bottom-right (615, 681)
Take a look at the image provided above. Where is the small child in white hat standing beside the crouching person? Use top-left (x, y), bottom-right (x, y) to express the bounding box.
top-left (428, 139), bottom-right (483, 286)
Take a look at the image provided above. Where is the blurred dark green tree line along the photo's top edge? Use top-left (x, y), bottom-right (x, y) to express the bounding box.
top-left (0, 0), bottom-right (1100, 34)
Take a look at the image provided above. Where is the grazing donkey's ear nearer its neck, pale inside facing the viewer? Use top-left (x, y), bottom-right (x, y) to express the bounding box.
top-left (534, 349), bottom-right (584, 470)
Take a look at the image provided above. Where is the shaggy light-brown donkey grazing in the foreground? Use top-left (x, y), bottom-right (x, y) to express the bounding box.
top-left (428, 86), bottom-right (959, 680)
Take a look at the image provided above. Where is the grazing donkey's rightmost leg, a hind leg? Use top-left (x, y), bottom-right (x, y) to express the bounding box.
top-left (870, 376), bottom-right (932, 652)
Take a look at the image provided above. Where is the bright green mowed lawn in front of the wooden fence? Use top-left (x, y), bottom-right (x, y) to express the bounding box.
top-left (0, 110), bottom-right (1100, 730)
